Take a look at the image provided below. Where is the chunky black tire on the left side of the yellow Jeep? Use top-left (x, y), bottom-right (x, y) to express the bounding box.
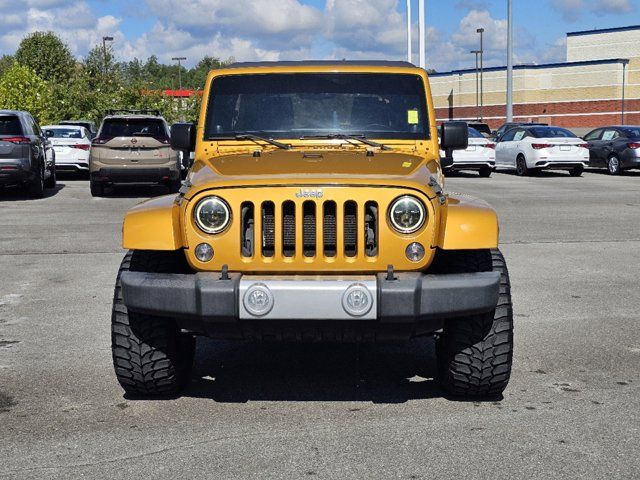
top-left (111, 251), bottom-right (195, 396)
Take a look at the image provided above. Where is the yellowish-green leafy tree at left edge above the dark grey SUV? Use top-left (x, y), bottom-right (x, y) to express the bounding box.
top-left (0, 63), bottom-right (56, 123)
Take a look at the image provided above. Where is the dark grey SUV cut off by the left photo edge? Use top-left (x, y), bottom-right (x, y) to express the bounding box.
top-left (0, 110), bottom-right (56, 198)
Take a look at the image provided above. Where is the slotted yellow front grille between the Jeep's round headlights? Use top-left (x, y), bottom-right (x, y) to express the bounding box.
top-left (240, 199), bottom-right (379, 260)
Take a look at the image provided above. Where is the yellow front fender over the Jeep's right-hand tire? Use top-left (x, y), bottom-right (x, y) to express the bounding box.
top-left (437, 194), bottom-right (500, 250)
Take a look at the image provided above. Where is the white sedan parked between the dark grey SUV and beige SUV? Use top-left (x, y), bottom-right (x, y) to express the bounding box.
top-left (42, 125), bottom-right (91, 172)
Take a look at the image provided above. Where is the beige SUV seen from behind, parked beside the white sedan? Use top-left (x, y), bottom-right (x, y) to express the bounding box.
top-left (89, 110), bottom-right (181, 197)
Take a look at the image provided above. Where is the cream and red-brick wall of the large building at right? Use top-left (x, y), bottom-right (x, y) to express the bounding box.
top-left (430, 27), bottom-right (640, 128)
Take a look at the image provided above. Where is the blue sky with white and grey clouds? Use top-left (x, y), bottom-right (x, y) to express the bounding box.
top-left (0, 0), bottom-right (640, 72)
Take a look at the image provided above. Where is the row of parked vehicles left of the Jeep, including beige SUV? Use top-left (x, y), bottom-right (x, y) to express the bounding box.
top-left (0, 110), bottom-right (191, 197)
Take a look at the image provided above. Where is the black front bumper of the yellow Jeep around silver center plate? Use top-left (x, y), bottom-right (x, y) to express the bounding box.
top-left (120, 272), bottom-right (500, 336)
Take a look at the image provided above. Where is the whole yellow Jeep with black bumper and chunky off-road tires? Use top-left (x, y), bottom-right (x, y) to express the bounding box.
top-left (112, 61), bottom-right (513, 398)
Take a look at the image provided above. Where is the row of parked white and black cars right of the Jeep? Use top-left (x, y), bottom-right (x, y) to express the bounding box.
top-left (440, 123), bottom-right (640, 177)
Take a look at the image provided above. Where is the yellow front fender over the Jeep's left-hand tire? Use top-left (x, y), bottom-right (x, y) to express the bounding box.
top-left (122, 195), bottom-right (185, 250)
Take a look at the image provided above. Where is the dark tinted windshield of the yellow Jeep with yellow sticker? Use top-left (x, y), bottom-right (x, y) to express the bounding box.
top-left (205, 73), bottom-right (429, 139)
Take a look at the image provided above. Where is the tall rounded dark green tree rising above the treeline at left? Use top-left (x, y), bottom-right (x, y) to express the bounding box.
top-left (15, 32), bottom-right (76, 82)
